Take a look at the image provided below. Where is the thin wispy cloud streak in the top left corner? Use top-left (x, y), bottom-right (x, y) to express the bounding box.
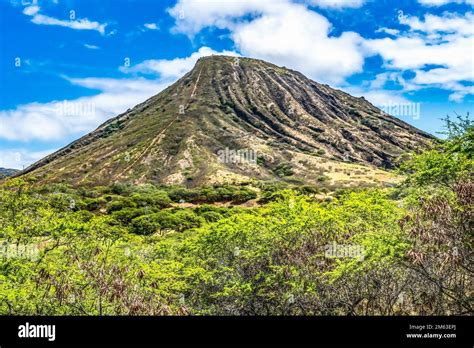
top-left (23, 5), bottom-right (107, 35)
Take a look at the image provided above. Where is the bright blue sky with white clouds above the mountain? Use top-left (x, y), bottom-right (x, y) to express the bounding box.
top-left (0, 0), bottom-right (474, 168)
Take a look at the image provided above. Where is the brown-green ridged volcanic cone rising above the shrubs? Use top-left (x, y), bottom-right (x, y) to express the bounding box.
top-left (20, 56), bottom-right (433, 186)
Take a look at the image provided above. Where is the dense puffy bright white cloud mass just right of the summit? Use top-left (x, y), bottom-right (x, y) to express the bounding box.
top-left (231, 6), bottom-right (364, 83)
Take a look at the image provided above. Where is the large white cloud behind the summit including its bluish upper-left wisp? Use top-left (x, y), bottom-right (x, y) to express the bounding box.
top-left (169, 0), bottom-right (364, 83)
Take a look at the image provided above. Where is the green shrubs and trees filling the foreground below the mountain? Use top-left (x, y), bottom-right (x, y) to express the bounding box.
top-left (0, 119), bottom-right (474, 315)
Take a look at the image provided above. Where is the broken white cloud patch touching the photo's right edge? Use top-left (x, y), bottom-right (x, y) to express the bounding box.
top-left (364, 12), bottom-right (474, 101)
